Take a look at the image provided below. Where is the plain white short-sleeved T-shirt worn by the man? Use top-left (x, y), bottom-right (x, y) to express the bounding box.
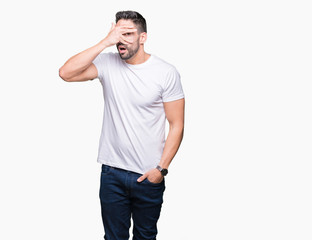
top-left (93, 53), bottom-right (184, 174)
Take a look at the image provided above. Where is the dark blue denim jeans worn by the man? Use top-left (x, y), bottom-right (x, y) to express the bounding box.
top-left (100, 164), bottom-right (165, 240)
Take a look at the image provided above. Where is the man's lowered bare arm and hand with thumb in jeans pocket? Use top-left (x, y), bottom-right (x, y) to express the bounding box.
top-left (138, 98), bottom-right (185, 183)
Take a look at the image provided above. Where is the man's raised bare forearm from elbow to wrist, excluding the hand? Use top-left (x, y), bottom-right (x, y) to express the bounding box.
top-left (60, 39), bottom-right (108, 78)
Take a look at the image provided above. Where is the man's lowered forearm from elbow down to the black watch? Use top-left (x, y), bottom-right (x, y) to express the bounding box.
top-left (159, 125), bottom-right (183, 169)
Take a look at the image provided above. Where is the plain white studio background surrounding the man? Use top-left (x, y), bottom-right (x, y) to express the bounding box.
top-left (0, 0), bottom-right (312, 240)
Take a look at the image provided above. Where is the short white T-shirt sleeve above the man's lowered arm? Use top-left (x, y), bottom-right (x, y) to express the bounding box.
top-left (162, 67), bottom-right (184, 102)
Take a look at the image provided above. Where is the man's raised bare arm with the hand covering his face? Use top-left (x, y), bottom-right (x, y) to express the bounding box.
top-left (59, 24), bottom-right (137, 82)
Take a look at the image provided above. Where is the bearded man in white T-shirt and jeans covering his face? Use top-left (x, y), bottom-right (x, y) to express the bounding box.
top-left (59, 11), bottom-right (184, 240)
